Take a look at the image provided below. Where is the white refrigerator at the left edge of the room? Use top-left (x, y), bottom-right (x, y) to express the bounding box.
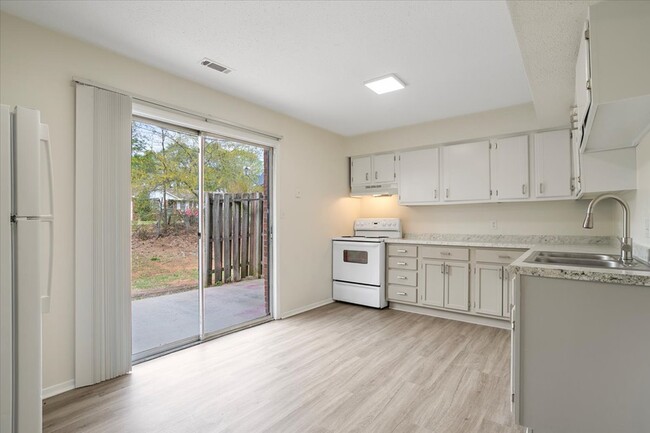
top-left (0, 105), bottom-right (54, 433)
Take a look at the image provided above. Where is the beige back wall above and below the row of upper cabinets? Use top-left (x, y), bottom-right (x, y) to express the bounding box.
top-left (346, 104), bottom-right (616, 236)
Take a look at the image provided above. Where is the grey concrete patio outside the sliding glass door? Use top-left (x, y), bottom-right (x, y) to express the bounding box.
top-left (132, 279), bottom-right (267, 354)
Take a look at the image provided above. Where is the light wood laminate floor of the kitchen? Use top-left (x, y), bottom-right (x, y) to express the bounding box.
top-left (44, 303), bottom-right (523, 433)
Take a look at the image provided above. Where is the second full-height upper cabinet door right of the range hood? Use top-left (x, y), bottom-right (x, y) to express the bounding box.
top-left (442, 141), bottom-right (490, 201)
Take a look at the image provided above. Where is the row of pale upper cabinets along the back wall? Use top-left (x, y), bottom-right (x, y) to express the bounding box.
top-left (350, 125), bottom-right (637, 206)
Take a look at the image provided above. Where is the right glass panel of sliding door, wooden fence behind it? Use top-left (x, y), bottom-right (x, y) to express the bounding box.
top-left (203, 136), bottom-right (271, 334)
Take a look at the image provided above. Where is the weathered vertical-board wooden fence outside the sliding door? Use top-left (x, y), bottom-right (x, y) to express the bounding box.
top-left (203, 192), bottom-right (265, 286)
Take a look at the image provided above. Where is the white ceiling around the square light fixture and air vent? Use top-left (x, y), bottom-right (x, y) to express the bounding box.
top-left (0, 0), bottom-right (572, 136)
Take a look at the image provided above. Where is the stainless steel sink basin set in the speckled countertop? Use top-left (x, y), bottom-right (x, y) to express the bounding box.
top-left (525, 251), bottom-right (650, 272)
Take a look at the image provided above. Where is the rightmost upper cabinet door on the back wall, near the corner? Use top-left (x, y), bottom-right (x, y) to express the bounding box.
top-left (535, 130), bottom-right (571, 198)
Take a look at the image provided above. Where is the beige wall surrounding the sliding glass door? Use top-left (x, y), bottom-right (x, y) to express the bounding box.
top-left (0, 14), bottom-right (359, 387)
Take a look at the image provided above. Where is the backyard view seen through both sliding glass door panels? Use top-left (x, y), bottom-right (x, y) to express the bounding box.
top-left (131, 120), bottom-right (268, 354)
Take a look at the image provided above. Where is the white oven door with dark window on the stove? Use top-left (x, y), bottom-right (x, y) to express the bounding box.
top-left (332, 241), bottom-right (385, 286)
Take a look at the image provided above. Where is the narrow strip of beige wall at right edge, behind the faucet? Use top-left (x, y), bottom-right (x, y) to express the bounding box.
top-left (617, 133), bottom-right (650, 260)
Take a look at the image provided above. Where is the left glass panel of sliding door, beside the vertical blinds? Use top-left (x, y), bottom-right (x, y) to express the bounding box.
top-left (131, 119), bottom-right (200, 360)
